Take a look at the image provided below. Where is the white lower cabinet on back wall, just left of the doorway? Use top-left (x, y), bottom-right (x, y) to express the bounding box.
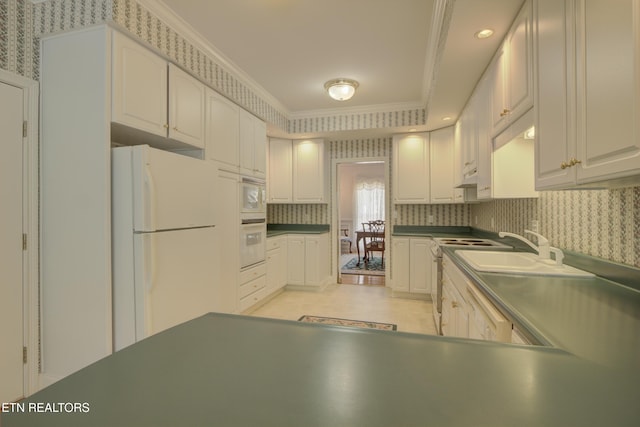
top-left (287, 233), bottom-right (330, 286)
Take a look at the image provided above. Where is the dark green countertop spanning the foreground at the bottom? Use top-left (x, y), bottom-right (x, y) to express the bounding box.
top-left (2, 314), bottom-right (640, 427)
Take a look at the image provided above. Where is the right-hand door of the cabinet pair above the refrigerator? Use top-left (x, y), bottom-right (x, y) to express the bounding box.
top-left (169, 64), bottom-right (205, 148)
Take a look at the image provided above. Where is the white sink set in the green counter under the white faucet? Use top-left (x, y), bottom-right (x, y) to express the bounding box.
top-left (456, 250), bottom-right (594, 277)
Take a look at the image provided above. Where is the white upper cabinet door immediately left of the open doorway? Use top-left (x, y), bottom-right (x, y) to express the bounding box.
top-left (293, 139), bottom-right (326, 203)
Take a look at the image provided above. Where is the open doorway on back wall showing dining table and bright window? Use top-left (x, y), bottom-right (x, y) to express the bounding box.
top-left (335, 160), bottom-right (388, 285)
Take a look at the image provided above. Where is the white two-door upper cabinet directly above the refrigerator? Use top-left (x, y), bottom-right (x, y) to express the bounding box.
top-left (111, 31), bottom-right (205, 148)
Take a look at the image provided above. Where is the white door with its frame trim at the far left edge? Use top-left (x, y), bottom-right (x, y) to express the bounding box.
top-left (0, 71), bottom-right (39, 402)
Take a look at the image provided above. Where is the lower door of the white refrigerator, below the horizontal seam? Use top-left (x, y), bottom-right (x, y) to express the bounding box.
top-left (134, 227), bottom-right (218, 340)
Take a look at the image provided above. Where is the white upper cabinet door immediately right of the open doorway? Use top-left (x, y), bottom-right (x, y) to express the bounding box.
top-left (393, 133), bottom-right (429, 204)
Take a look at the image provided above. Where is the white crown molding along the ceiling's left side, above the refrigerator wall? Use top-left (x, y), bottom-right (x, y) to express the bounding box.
top-left (136, 0), bottom-right (291, 117)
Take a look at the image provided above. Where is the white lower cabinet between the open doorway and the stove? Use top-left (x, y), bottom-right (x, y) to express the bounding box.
top-left (391, 237), bottom-right (434, 294)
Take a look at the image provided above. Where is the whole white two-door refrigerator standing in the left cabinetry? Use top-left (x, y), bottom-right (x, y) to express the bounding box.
top-left (112, 145), bottom-right (216, 350)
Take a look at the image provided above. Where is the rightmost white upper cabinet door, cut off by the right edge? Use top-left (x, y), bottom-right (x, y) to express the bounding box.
top-left (575, 0), bottom-right (640, 183)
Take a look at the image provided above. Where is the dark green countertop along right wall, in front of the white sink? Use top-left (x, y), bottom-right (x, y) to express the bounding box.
top-left (443, 247), bottom-right (640, 372)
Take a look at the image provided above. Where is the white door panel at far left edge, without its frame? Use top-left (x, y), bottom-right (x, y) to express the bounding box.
top-left (0, 83), bottom-right (24, 402)
